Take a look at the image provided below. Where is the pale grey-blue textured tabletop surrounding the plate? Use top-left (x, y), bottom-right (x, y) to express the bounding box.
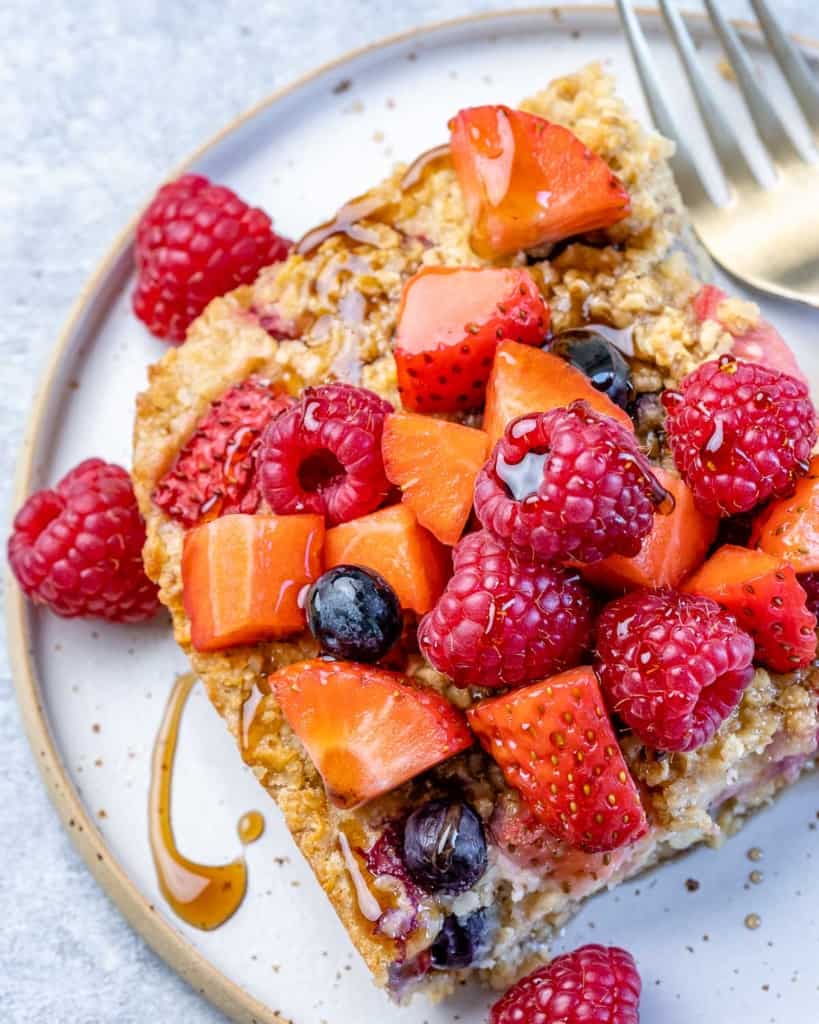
top-left (0, 0), bottom-right (819, 1024)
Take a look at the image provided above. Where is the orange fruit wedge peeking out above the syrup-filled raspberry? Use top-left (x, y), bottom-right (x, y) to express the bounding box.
top-left (483, 341), bottom-right (634, 444)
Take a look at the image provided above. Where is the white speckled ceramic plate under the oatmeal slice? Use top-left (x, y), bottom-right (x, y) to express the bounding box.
top-left (8, 7), bottom-right (819, 1024)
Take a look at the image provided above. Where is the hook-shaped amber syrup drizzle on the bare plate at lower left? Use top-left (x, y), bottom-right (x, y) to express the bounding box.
top-left (148, 674), bottom-right (246, 931)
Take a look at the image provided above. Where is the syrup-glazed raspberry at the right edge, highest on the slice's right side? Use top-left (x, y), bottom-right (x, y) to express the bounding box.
top-left (662, 355), bottom-right (816, 516)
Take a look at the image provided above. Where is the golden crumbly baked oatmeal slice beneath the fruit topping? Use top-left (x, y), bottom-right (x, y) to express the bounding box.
top-left (133, 66), bottom-right (819, 998)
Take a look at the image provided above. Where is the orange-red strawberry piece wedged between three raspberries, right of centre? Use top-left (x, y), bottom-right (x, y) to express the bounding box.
top-left (577, 466), bottom-right (719, 591)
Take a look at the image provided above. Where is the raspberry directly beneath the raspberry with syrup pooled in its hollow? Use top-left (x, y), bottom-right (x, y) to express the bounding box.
top-left (418, 530), bottom-right (592, 687)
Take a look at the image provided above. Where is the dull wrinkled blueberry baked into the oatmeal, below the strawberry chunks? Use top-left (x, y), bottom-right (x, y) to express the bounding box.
top-left (403, 800), bottom-right (486, 893)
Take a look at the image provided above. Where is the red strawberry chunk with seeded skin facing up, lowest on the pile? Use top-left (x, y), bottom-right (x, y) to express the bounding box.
top-left (467, 667), bottom-right (648, 853)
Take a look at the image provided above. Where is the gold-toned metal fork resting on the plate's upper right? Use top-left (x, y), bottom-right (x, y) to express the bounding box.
top-left (617, 0), bottom-right (819, 308)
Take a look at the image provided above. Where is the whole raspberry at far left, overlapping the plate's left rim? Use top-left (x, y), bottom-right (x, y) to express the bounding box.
top-left (8, 459), bottom-right (159, 623)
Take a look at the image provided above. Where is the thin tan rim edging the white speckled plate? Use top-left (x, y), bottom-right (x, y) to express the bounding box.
top-left (4, 3), bottom-right (819, 1024)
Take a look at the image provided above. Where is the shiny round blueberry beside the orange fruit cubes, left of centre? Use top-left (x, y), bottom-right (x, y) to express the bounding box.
top-left (306, 565), bottom-right (401, 662)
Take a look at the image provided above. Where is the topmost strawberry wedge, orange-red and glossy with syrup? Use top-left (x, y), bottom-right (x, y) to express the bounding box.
top-left (449, 106), bottom-right (630, 259)
